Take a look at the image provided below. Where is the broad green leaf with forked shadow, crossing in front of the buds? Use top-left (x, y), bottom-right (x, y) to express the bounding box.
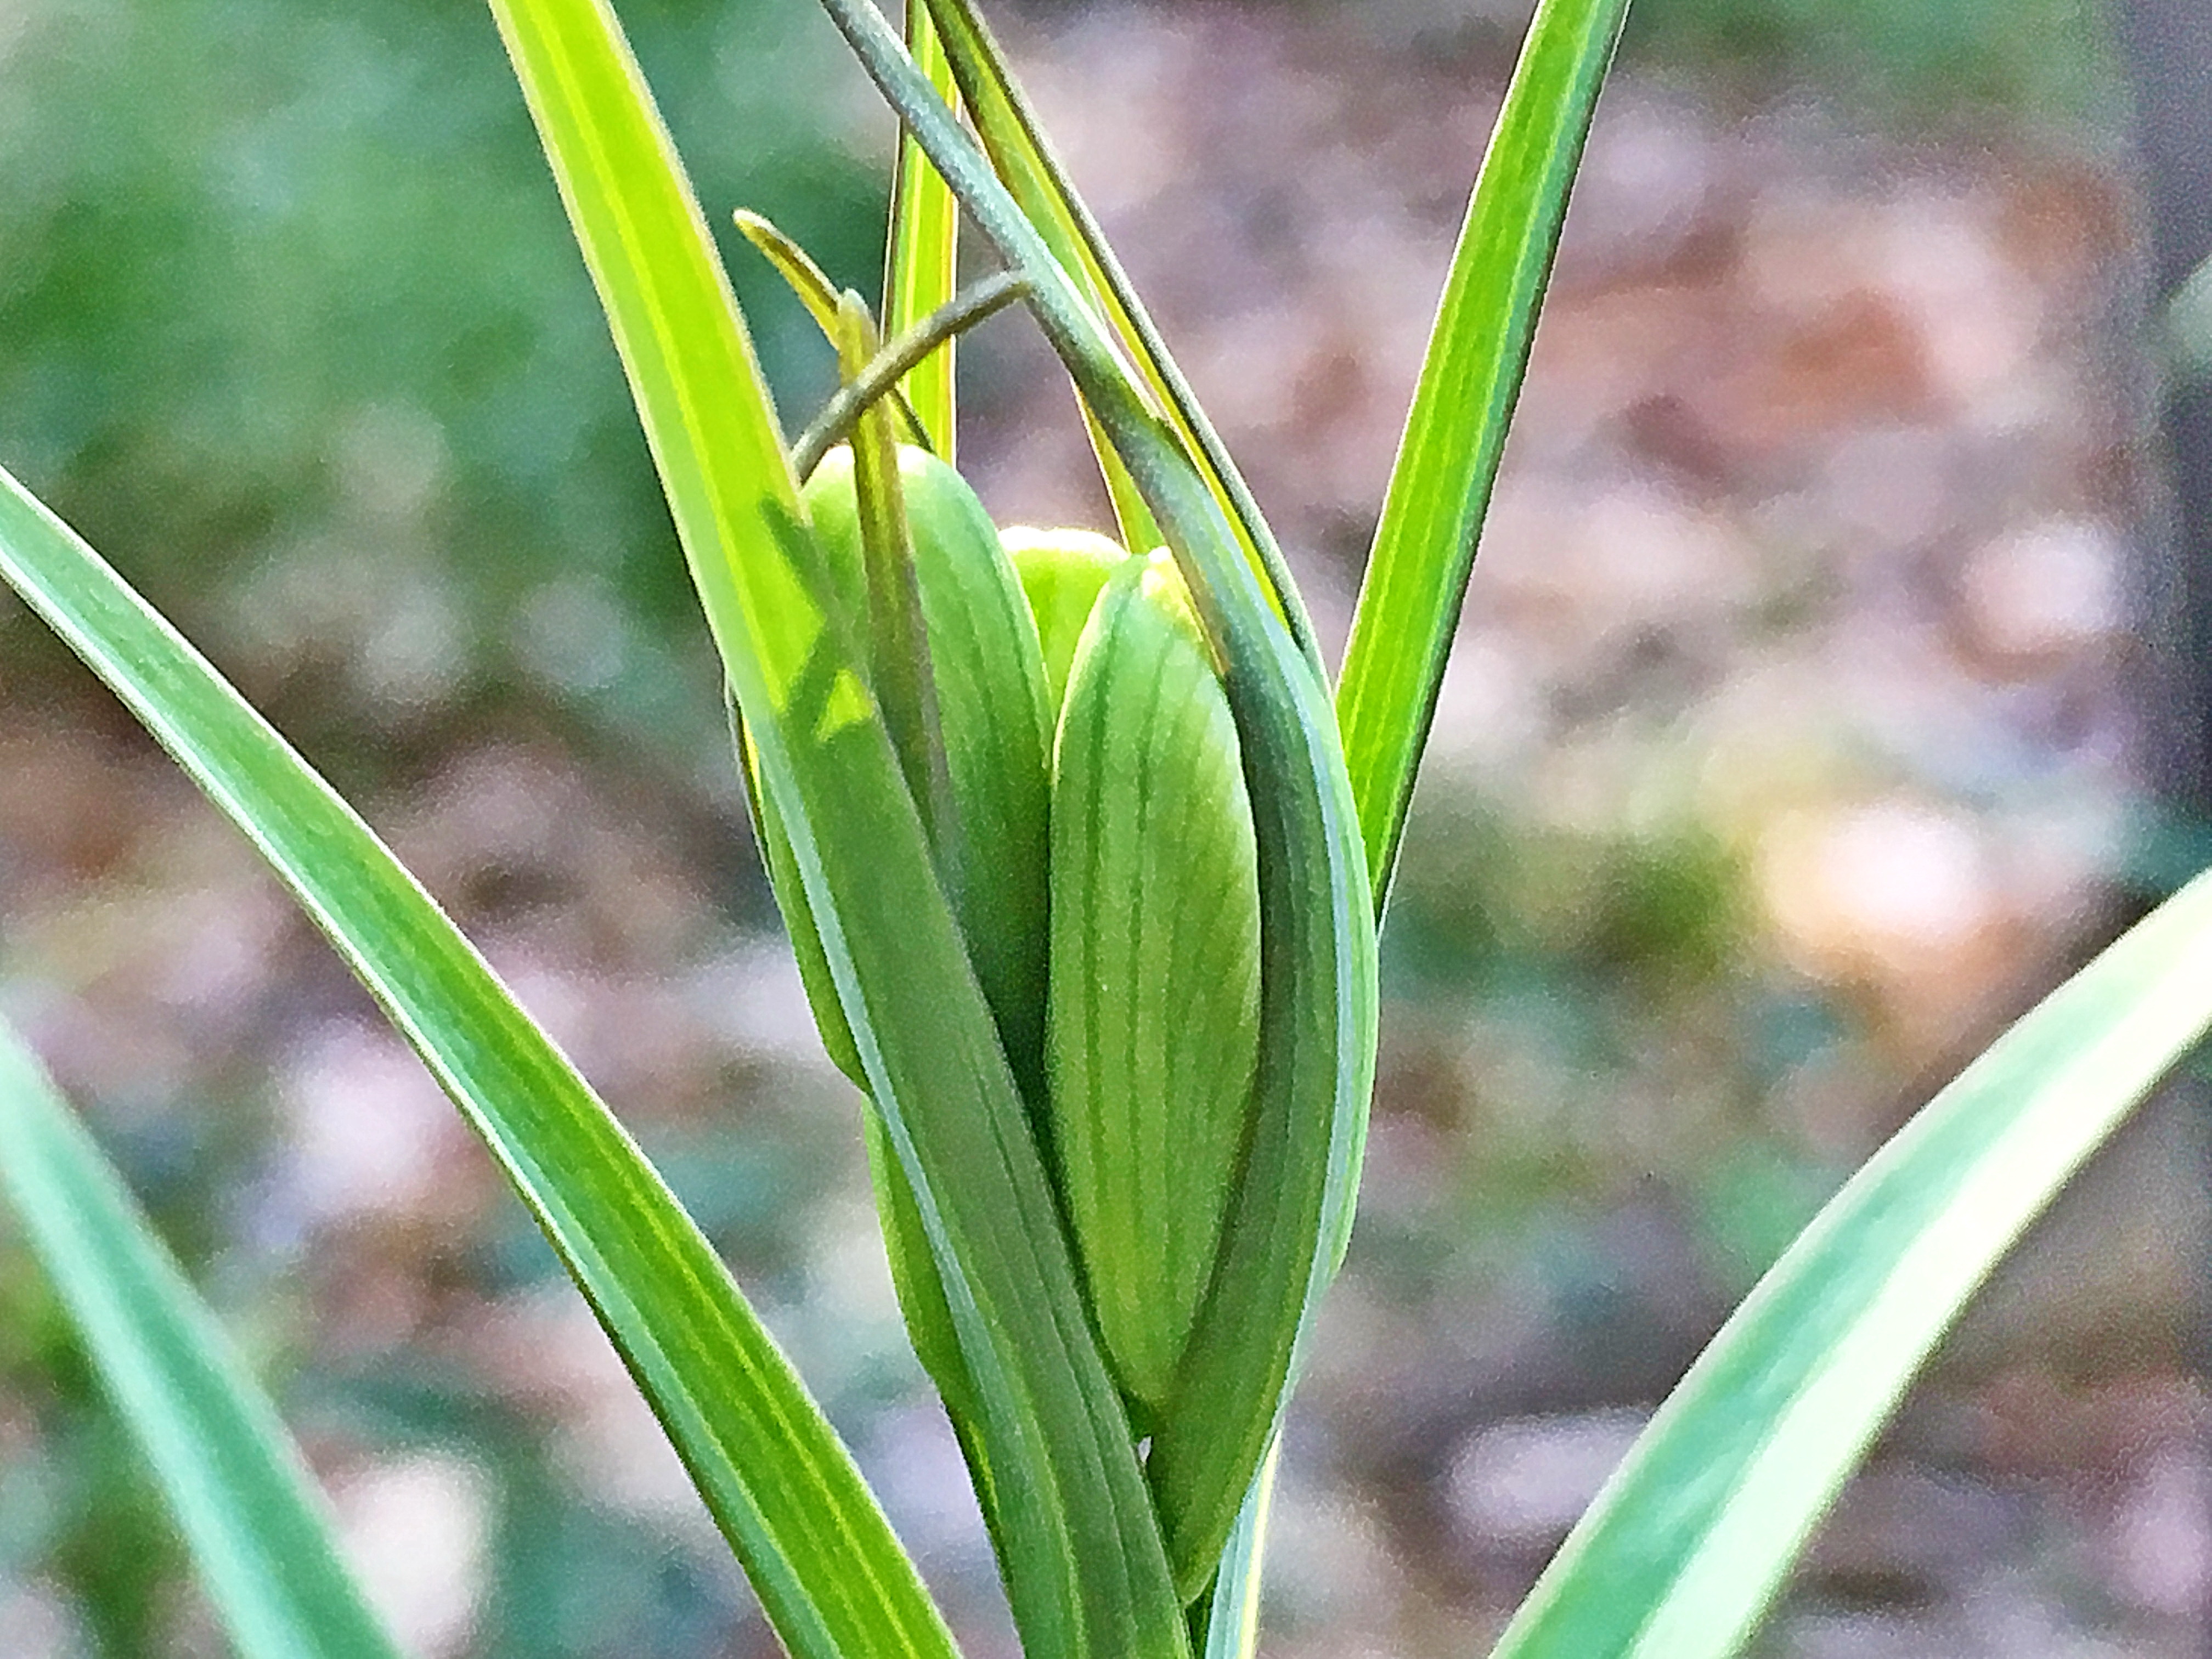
top-left (477, 0), bottom-right (1186, 1659)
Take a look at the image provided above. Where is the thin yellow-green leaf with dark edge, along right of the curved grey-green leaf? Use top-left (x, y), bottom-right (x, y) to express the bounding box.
top-left (911, 0), bottom-right (1321, 675)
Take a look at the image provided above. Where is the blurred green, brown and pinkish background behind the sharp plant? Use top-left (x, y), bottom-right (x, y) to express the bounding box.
top-left (0, 0), bottom-right (2212, 1659)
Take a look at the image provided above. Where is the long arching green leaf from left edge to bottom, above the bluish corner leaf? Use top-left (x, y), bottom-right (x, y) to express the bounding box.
top-left (0, 473), bottom-right (953, 1659)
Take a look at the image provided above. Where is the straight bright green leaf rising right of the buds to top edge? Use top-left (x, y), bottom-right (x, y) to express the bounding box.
top-left (1336, 0), bottom-right (1628, 907)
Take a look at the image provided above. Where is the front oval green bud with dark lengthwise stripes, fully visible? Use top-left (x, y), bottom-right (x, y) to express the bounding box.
top-left (1046, 551), bottom-right (1259, 1411)
